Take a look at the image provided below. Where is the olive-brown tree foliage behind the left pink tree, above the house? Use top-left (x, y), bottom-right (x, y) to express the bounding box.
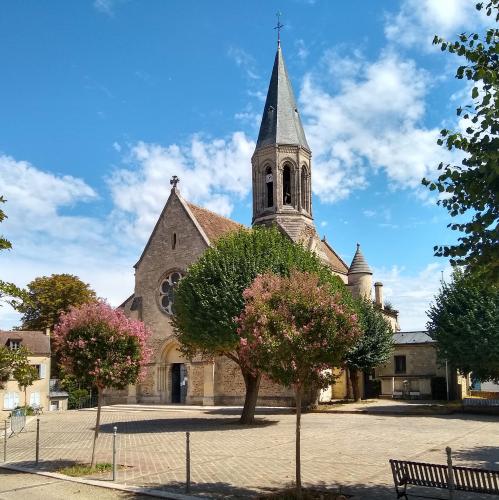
top-left (15, 274), bottom-right (97, 330)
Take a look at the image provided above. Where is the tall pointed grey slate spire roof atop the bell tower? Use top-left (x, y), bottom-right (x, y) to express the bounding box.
top-left (256, 47), bottom-right (310, 151)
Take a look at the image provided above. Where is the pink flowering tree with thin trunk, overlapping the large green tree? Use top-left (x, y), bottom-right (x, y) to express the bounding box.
top-left (238, 271), bottom-right (361, 498)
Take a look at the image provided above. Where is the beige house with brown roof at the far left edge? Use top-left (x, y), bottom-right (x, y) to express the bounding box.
top-left (0, 331), bottom-right (50, 419)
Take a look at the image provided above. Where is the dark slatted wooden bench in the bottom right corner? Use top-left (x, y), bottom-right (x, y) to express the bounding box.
top-left (390, 448), bottom-right (499, 499)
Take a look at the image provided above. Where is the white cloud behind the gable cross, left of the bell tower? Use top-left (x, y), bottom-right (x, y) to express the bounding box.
top-left (108, 132), bottom-right (255, 239)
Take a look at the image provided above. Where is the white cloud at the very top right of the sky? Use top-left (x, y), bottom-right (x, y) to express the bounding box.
top-left (385, 0), bottom-right (486, 50)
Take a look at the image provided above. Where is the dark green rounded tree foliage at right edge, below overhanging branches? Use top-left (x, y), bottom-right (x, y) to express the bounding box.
top-left (426, 270), bottom-right (499, 381)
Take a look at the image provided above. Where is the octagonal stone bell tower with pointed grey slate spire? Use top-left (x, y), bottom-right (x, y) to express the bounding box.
top-left (251, 41), bottom-right (315, 241)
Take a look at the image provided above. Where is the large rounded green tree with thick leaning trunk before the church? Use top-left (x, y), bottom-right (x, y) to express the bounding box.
top-left (173, 227), bottom-right (352, 424)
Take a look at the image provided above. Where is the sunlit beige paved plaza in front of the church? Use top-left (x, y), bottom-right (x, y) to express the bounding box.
top-left (0, 406), bottom-right (499, 499)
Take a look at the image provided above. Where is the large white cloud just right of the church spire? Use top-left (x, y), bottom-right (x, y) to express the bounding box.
top-left (300, 51), bottom-right (449, 202)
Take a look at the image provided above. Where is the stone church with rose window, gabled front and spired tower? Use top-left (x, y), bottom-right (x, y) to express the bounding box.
top-left (111, 43), bottom-right (398, 406)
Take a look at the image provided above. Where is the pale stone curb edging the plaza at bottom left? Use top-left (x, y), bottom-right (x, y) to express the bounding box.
top-left (0, 463), bottom-right (205, 500)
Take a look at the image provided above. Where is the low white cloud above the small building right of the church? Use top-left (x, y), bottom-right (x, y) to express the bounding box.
top-left (375, 262), bottom-right (451, 331)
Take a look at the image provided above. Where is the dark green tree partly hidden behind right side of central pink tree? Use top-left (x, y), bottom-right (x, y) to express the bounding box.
top-left (345, 299), bottom-right (393, 401)
